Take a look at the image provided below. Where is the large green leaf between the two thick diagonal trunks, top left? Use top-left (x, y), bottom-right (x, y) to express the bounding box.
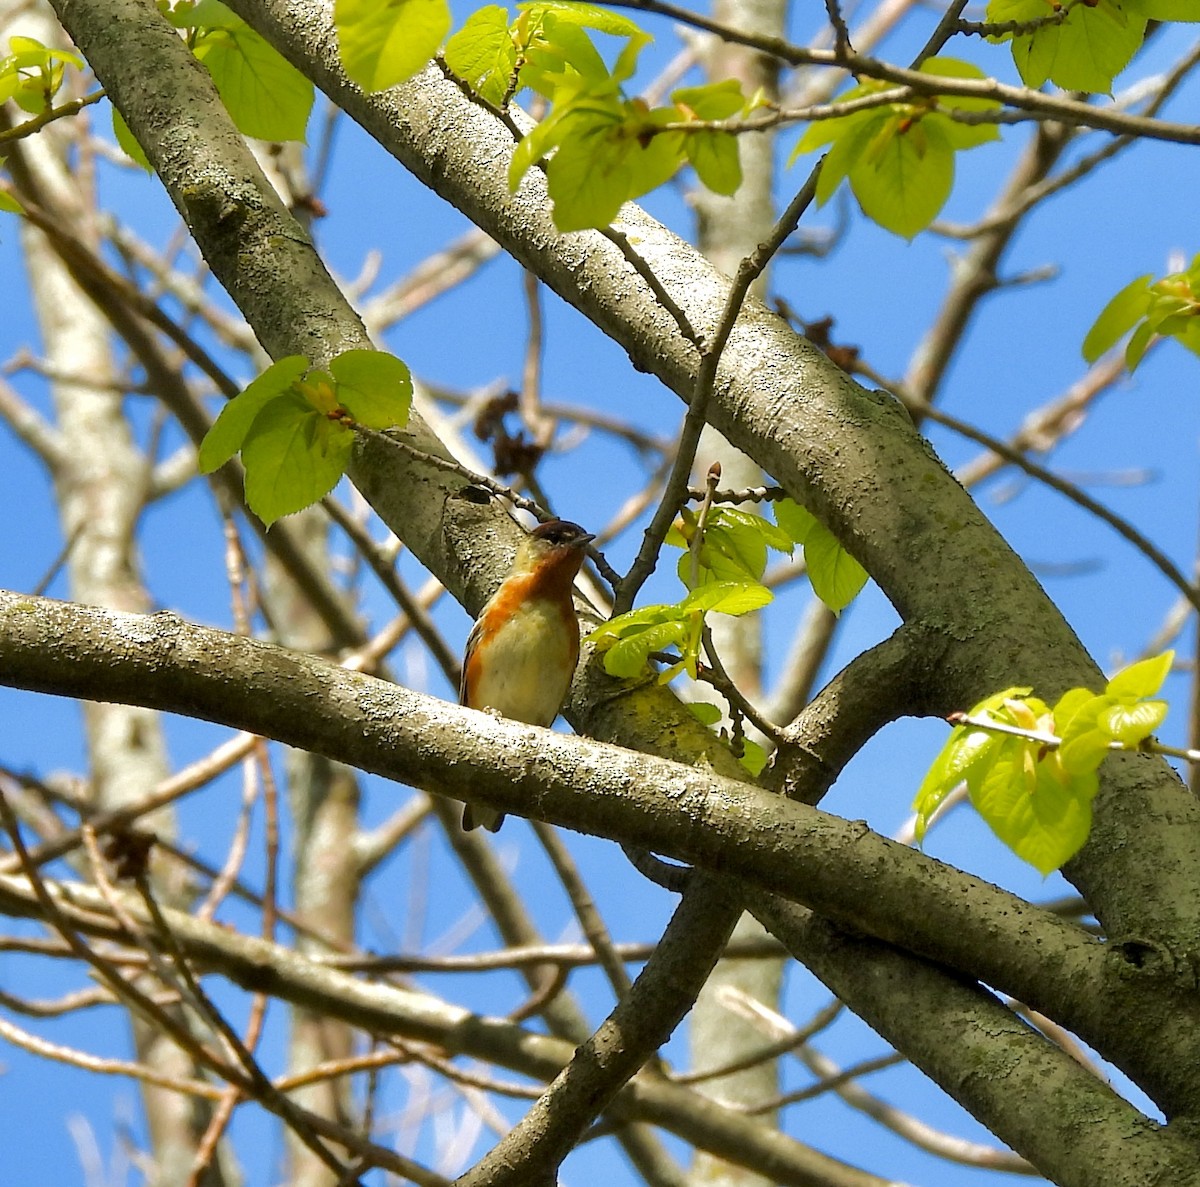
top-left (192, 0), bottom-right (313, 140)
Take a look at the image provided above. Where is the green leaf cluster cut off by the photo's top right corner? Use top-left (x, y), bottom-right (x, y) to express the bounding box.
top-left (986, 0), bottom-right (1200, 95)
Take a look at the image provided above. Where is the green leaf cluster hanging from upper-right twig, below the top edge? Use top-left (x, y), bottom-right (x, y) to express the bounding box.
top-left (792, 58), bottom-right (1001, 239)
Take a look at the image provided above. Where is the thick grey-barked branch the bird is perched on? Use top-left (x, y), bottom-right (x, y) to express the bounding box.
top-left (0, 594), bottom-right (1200, 1113)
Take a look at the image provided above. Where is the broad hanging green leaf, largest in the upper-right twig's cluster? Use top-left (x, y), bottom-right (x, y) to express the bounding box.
top-left (850, 119), bottom-right (954, 239)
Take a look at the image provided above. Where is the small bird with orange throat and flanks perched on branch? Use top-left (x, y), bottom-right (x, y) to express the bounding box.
top-left (458, 520), bottom-right (595, 833)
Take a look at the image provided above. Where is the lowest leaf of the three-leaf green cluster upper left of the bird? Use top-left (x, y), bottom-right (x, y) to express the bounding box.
top-left (241, 392), bottom-right (354, 527)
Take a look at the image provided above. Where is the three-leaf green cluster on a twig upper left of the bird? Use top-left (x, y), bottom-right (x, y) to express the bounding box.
top-left (199, 350), bottom-right (413, 524)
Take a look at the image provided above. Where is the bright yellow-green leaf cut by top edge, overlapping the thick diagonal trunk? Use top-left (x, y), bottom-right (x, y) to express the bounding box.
top-left (334, 0), bottom-right (450, 91)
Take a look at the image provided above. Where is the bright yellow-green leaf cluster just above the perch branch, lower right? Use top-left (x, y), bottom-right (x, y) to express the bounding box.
top-left (913, 652), bottom-right (1174, 874)
